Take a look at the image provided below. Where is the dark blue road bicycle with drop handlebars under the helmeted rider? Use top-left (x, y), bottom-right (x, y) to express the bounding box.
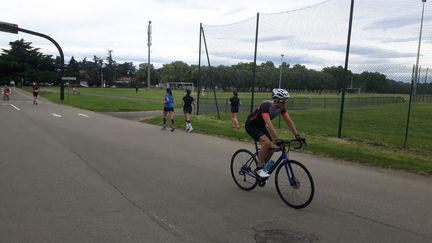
top-left (231, 139), bottom-right (315, 209)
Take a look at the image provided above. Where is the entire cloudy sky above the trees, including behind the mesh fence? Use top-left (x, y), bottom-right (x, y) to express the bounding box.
top-left (0, 0), bottom-right (432, 81)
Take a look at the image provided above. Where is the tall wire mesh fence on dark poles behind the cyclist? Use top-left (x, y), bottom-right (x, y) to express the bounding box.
top-left (200, 0), bottom-right (432, 149)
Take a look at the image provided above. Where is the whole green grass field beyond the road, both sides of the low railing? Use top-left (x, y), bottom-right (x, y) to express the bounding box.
top-left (27, 88), bottom-right (432, 174)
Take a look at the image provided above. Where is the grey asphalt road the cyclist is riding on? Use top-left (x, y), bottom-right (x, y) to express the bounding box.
top-left (0, 91), bottom-right (432, 242)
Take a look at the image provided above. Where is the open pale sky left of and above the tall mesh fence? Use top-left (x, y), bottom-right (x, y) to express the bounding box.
top-left (0, 0), bottom-right (322, 66)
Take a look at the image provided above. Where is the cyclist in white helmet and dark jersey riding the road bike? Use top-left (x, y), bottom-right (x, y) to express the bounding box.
top-left (245, 89), bottom-right (305, 178)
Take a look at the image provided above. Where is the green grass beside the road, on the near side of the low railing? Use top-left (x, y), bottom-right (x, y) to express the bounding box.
top-left (149, 104), bottom-right (432, 174)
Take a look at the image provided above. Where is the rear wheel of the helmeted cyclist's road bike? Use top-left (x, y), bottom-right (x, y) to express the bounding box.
top-left (231, 149), bottom-right (258, 191)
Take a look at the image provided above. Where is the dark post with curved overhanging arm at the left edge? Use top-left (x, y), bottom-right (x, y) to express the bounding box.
top-left (0, 22), bottom-right (64, 100)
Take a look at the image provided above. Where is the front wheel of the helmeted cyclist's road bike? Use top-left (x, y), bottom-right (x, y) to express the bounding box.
top-left (275, 160), bottom-right (315, 209)
